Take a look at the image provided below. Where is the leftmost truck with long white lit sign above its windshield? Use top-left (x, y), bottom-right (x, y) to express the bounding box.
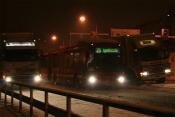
top-left (2, 33), bottom-right (41, 82)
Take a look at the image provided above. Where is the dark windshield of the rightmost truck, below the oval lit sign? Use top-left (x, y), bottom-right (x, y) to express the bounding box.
top-left (135, 48), bottom-right (168, 61)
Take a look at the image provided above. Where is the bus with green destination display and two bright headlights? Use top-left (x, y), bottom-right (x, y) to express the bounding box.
top-left (41, 39), bottom-right (141, 87)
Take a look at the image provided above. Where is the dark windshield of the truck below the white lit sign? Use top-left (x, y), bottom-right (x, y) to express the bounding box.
top-left (5, 49), bottom-right (38, 61)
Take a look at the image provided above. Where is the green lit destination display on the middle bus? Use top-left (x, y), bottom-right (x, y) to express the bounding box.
top-left (95, 48), bottom-right (120, 54)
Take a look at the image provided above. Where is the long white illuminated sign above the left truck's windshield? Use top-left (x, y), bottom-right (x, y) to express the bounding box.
top-left (6, 42), bottom-right (35, 47)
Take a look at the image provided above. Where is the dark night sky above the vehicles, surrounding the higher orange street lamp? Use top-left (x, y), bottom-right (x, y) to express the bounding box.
top-left (0, 0), bottom-right (175, 33)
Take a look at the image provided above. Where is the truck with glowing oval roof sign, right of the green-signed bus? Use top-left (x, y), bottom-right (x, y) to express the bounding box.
top-left (113, 34), bottom-right (171, 83)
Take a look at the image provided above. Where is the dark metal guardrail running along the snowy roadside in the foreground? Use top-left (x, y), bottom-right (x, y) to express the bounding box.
top-left (0, 83), bottom-right (175, 117)
